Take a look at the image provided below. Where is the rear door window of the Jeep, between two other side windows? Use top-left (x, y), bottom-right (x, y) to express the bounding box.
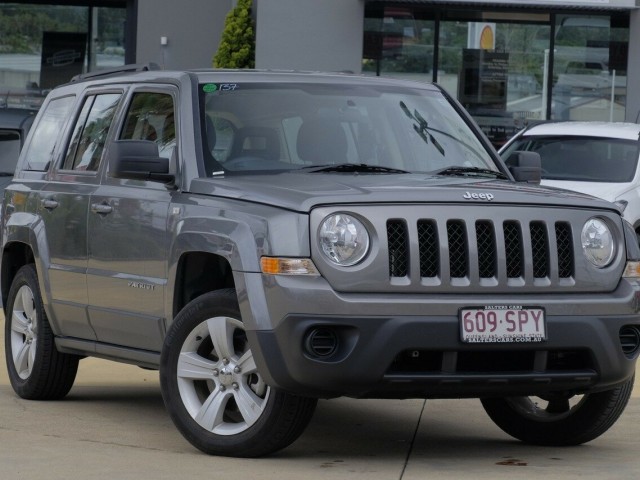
top-left (63, 93), bottom-right (121, 171)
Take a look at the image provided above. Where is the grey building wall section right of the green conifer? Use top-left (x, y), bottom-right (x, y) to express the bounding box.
top-left (255, 0), bottom-right (364, 72)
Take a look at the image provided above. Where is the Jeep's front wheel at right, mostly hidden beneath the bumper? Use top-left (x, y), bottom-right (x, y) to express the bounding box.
top-left (482, 378), bottom-right (633, 446)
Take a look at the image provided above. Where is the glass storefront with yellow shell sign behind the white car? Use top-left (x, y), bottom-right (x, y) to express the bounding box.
top-left (363, 2), bottom-right (629, 146)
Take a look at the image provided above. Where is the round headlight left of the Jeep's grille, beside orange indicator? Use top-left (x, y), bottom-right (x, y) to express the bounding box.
top-left (319, 213), bottom-right (369, 267)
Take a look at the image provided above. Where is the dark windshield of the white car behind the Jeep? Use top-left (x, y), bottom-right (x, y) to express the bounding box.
top-left (501, 135), bottom-right (638, 183)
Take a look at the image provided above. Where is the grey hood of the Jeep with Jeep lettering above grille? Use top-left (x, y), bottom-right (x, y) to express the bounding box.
top-left (190, 173), bottom-right (617, 212)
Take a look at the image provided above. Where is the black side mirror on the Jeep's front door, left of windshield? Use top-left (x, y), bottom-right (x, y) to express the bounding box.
top-left (107, 140), bottom-right (175, 183)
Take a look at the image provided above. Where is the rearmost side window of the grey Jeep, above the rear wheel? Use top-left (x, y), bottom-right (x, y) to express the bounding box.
top-left (25, 96), bottom-right (75, 171)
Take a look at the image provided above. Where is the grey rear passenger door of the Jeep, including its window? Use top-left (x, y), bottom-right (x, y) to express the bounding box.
top-left (34, 91), bottom-right (122, 340)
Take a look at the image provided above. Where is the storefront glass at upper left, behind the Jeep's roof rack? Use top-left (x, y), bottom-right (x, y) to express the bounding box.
top-left (0, 2), bottom-right (126, 108)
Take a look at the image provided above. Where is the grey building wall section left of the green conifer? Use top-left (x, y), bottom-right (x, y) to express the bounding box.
top-left (135, 0), bottom-right (231, 69)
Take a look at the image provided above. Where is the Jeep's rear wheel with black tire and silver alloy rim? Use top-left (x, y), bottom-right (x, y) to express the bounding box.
top-left (4, 264), bottom-right (80, 400)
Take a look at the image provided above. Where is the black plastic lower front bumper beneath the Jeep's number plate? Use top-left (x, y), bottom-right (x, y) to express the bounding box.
top-left (248, 315), bottom-right (640, 398)
